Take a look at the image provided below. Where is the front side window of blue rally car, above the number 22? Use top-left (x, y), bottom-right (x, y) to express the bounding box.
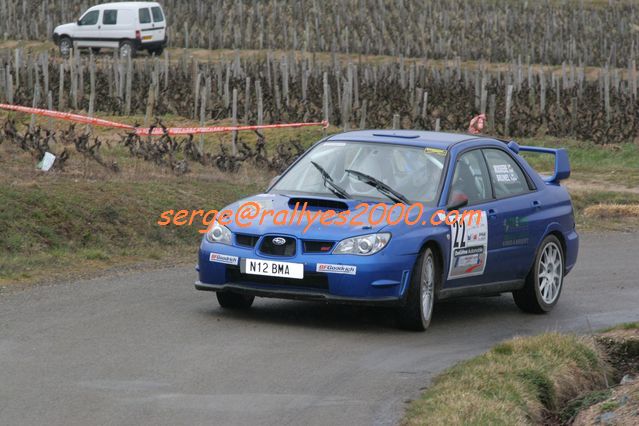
top-left (448, 149), bottom-right (492, 205)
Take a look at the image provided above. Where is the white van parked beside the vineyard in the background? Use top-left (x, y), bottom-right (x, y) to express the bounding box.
top-left (53, 1), bottom-right (167, 57)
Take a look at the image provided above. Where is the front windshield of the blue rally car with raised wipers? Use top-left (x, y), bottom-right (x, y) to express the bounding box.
top-left (271, 141), bottom-right (446, 206)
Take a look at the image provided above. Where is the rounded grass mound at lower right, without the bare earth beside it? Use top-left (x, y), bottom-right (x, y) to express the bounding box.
top-left (403, 333), bottom-right (608, 425)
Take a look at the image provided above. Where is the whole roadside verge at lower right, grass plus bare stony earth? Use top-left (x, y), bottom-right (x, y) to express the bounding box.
top-left (402, 322), bottom-right (639, 425)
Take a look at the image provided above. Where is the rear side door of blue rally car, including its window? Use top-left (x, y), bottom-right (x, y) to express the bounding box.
top-left (482, 148), bottom-right (541, 281)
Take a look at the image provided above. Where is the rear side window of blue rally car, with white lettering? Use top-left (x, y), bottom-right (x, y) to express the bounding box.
top-left (484, 149), bottom-right (530, 198)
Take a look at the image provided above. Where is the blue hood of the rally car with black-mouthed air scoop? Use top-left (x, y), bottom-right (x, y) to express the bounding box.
top-left (220, 194), bottom-right (408, 241)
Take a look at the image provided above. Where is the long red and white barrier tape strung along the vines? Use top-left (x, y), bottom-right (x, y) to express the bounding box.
top-left (0, 104), bottom-right (328, 136)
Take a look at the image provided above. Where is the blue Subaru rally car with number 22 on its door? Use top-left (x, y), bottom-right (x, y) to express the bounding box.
top-left (195, 130), bottom-right (579, 330)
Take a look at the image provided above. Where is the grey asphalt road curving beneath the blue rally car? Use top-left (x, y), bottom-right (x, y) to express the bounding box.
top-left (0, 234), bottom-right (639, 426)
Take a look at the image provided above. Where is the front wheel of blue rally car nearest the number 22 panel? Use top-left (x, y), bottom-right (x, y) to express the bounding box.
top-left (397, 248), bottom-right (441, 331)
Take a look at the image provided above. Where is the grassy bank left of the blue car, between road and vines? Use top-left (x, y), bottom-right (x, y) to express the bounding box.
top-left (0, 175), bottom-right (259, 283)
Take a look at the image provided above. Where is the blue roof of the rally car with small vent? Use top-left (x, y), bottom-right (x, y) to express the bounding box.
top-left (326, 130), bottom-right (486, 149)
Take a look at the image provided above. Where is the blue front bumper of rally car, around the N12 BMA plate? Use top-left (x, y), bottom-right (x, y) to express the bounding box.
top-left (195, 239), bottom-right (416, 305)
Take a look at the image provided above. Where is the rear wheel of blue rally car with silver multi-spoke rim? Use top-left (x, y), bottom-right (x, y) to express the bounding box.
top-left (513, 235), bottom-right (565, 314)
